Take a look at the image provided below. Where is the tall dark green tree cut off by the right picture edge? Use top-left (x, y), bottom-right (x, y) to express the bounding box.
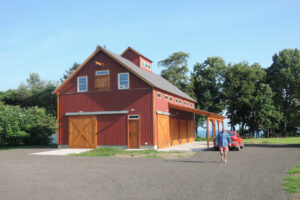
top-left (266, 49), bottom-right (300, 135)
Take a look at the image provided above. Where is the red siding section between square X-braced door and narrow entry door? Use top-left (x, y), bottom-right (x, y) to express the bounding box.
top-left (97, 115), bottom-right (127, 145)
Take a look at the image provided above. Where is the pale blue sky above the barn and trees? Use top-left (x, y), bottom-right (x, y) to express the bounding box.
top-left (0, 0), bottom-right (300, 91)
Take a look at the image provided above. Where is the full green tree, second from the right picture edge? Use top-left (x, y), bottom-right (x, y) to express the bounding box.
top-left (224, 62), bottom-right (265, 132)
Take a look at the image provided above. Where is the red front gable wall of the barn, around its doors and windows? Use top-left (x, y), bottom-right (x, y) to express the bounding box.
top-left (59, 52), bottom-right (153, 145)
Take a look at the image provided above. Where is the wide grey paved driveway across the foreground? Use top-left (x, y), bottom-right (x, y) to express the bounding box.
top-left (0, 146), bottom-right (300, 200)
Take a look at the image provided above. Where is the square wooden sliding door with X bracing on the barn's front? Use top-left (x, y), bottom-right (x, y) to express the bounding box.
top-left (69, 116), bottom-right (97, 148)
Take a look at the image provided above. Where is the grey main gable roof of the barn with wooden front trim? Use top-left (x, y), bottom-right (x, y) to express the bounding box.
top-left (53, 47), bottom-right (196, 102)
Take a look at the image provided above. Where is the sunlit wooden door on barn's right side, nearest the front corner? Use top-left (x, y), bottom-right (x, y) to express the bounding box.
top-left (157, 115), bottom-right (170, 149)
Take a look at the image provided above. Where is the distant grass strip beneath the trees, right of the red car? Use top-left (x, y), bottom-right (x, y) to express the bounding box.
top-left (244, 137), bottom-right (300, 144)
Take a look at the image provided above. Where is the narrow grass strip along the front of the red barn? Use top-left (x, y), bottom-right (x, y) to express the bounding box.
top-left (73, 148), bottom-right (195, 159)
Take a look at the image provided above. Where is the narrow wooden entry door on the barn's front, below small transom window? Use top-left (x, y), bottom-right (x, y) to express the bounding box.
top-left (128, 119), bottom-right (140, 148)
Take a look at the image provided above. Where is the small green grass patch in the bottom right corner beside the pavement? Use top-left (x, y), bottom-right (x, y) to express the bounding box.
top-left (281, 165), bottom-right (300, 193)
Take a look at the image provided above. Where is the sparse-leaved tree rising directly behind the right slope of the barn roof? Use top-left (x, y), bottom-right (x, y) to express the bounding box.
top-left (158, 51), bottom-right (191, 92)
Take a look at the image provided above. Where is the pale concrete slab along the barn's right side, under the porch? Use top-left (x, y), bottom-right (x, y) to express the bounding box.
top-left (158, 141), bottom-right (213, 152)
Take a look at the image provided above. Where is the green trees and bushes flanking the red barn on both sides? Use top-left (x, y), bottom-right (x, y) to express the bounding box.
top-left (0, 49), bottom-right (300, 145)
